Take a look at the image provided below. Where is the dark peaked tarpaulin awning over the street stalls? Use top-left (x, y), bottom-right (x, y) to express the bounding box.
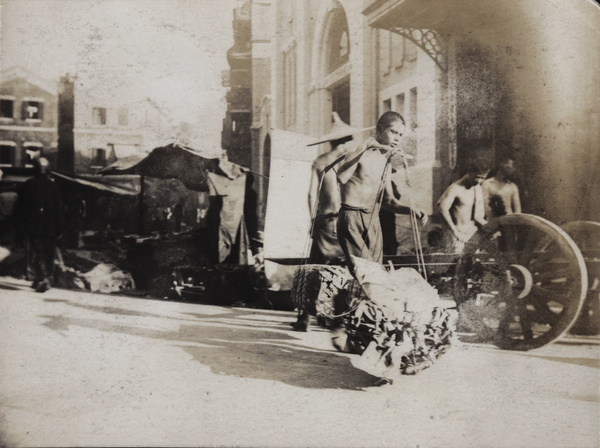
top-left (100, 143), bottom-right (244, 192)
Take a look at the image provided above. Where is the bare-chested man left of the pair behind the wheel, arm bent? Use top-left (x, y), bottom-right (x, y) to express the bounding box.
top-left (439, 159), bottom-right (490, 253)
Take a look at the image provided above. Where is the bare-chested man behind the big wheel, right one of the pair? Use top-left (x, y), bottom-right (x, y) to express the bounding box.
top-left (481, 156), bottom-right (521, 220)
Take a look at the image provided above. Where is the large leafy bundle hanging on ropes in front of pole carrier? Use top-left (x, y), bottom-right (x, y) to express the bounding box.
top-left (334, 257), bottom-right (456, 380)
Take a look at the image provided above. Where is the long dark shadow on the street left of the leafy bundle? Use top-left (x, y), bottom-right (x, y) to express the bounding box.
top-left (40, 300), bottom-right (379, 390)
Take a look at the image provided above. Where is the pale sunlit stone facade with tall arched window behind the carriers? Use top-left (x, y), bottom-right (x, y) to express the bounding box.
top-left (253, 0), bottom-right (441, 254)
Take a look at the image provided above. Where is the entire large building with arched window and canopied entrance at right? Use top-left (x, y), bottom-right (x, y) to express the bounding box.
top-left (258, 0), bottom-right (600, 245)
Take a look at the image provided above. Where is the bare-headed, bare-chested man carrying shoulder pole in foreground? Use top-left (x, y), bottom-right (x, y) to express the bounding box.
top-left (337, 111), bottom-right (427, 268)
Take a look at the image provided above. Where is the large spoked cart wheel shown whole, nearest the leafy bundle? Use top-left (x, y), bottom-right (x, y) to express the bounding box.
top-left (455, 214), bottom-right (587, 350)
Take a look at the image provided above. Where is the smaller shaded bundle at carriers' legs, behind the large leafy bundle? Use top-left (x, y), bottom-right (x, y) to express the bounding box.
top-left (291, 264), bottom-right (353, 326)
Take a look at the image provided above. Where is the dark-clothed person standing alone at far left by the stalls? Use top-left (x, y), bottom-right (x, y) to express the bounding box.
top-left (16, 157), bottom-right (63, 292)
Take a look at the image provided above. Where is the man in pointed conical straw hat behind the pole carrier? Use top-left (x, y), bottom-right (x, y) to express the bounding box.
top-left (293, 112), bottom-right (372, 331)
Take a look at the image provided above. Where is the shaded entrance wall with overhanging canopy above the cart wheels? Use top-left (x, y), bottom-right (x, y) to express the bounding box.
top-left (362, 0), bottom-right (600, 225)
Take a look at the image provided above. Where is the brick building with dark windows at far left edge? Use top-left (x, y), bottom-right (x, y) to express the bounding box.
top-left (0, 67), bottom-right (58, 169)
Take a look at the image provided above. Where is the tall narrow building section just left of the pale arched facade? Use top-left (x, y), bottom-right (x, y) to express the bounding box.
top-left (221, 0), bottom-right (275, 234)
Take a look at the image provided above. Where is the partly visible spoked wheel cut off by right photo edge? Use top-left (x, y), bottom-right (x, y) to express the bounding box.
top-left (562, 221), bottom-right (600, 335)
